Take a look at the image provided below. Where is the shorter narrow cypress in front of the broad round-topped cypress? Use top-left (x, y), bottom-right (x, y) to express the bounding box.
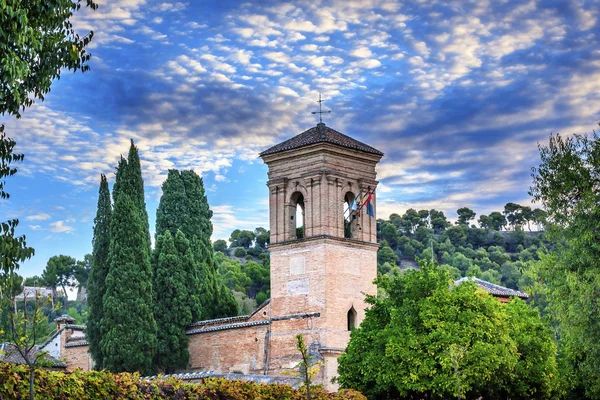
top-left (154, 230), bottom-right (194, 373)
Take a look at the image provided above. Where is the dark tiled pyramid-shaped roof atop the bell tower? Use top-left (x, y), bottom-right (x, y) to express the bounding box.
top-left (260, 122), bottom-right (383, 157)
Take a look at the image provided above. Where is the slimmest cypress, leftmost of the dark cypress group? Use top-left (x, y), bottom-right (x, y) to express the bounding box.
top-left (86, 174), bottom-right (112, 367)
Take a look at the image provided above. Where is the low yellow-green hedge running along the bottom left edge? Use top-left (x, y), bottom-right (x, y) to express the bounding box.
top-left (0, 363), bottom-right (365, 400)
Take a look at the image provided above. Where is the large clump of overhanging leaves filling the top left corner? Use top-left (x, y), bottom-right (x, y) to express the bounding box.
top-left (0, 0), bottom-right (98, 117)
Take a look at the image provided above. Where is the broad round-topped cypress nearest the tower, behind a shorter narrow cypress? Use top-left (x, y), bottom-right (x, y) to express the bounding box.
top-left (154, 170), bottom-right (237, 320)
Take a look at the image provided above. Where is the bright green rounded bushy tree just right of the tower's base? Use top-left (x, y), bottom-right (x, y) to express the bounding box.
top-left (338, 262), bottom-right (556, 398)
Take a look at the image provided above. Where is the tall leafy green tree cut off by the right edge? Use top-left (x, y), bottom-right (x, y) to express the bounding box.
top-left (530, 132), bottom-right (600, 398)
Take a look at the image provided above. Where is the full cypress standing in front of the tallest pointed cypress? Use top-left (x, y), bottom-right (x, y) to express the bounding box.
top-left (100, 192), bottom-right (156, 374)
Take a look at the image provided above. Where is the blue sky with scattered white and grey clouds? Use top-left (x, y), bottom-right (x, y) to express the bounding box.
top-left (0, 0), bottom-right (600, 276)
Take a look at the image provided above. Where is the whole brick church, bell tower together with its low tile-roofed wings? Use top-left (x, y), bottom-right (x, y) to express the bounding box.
top-left (47, 122), bottom-right (383, 390)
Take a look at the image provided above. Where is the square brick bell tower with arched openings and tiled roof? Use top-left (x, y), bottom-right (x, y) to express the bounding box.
top-left (260, 123), bottom-right (383, 389)
